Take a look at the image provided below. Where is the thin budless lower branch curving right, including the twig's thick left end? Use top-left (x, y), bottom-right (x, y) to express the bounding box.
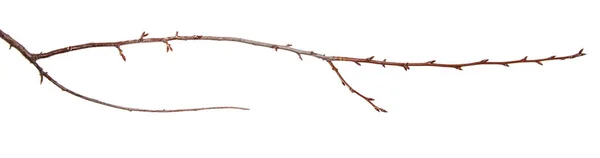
top-left (0, 29), bottom-right (249, 112)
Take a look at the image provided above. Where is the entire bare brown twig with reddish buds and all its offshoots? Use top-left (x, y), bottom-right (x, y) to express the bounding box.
top-left (0, 30), bottom-right (586, 112)
